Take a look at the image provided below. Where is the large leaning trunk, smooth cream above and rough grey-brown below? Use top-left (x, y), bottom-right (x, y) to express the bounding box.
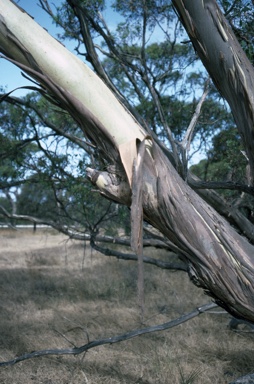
top-left (0, 0), bottom-right (254, 322)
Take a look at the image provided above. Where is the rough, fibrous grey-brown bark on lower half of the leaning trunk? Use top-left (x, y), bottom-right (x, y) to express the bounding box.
top-left (143, 144), bottom-right (254, 322)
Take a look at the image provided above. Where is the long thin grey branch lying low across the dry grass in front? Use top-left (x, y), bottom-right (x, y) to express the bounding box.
top-left (0, 303), bottom-right (217, 367)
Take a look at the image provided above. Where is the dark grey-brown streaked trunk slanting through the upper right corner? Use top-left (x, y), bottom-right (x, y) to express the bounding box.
top-left (172, 0), bottom-right (254, 185)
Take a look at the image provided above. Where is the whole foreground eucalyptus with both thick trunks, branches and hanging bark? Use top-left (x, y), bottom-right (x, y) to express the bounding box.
top-left (0, 0), bottom-right (254, 328)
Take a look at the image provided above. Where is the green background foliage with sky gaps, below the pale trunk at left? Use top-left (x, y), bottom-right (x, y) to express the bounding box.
top-left (0, 93), bottom-right (129, 234)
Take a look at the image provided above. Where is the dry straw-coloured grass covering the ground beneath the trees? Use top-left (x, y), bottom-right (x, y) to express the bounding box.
top-left (0, 230), bottom-right (254, 384)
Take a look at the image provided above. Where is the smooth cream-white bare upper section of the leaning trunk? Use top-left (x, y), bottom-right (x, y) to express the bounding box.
top-left (0, 0), bottom-right (145, 148)
